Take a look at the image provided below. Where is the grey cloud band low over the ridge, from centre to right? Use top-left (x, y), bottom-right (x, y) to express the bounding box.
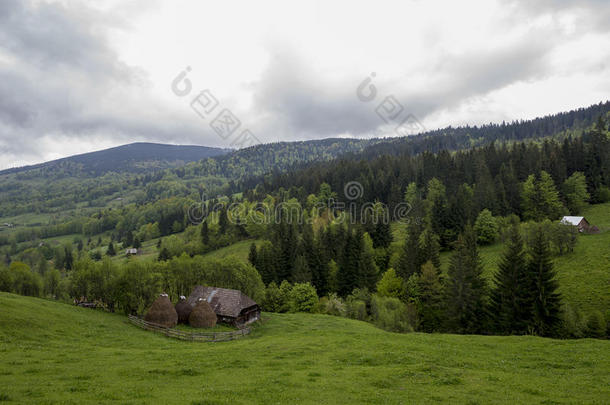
top-left (249, 36), bottom-right (553, 138)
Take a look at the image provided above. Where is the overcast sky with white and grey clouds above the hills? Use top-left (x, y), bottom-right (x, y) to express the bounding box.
top-left (0, 0), bottom-right (610, 169)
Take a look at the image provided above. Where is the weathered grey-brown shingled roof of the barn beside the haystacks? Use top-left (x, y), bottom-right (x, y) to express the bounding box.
top-left (186, 285), bottom-right (258, 318)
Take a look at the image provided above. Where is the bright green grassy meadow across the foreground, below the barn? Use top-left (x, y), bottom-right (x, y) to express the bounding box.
top-left (0, 293), bottom-right (610, 404)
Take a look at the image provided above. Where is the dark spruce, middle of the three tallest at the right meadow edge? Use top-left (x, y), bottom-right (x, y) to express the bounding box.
top-left (491, 224), bottom-right (533, 334)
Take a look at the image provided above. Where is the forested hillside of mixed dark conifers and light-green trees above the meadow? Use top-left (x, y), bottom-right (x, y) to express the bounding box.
top-left (0, 103), bottom-right (610, 337)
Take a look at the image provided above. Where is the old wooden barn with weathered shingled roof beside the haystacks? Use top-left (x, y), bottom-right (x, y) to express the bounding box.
top-left (187, 285), bottom-right (261, 327)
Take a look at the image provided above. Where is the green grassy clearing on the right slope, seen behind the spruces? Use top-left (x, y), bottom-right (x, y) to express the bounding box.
top-left (441, 203), bottom-right (610, 312)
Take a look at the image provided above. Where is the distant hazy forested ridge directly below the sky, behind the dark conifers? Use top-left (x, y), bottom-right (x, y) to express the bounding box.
top-left (0, 102), bottom-right (610, 222)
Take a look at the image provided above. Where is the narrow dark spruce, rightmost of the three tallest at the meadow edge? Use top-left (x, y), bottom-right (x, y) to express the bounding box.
top-left (527, 225), bottom-right (561, 336)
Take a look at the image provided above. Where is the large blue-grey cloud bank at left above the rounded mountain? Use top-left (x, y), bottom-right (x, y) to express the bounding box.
top-left (0, 0), bottom-right (211, 166)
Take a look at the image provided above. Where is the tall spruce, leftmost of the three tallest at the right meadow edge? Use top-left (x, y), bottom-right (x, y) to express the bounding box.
top-left (446, 225), bottom-right (487, 333)
